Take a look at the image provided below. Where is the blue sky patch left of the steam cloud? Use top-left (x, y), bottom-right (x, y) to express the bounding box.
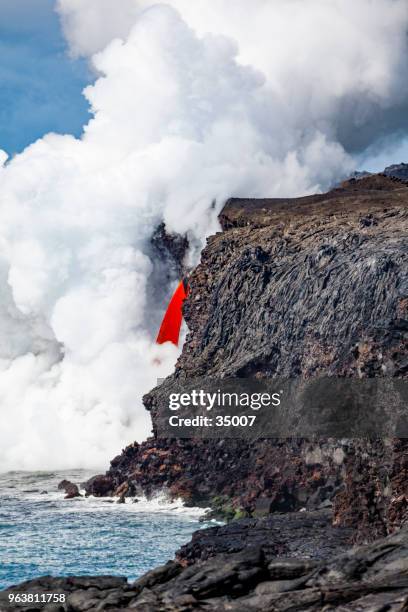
top-left (0, 0), bottom-right (92, 155)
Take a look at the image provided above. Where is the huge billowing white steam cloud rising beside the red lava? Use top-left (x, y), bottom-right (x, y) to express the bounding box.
top-left (0, 0), bottom-right (408, 469)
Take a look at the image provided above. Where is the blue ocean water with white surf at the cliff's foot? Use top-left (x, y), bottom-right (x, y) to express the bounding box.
top-left (0, 470), bottom-right (208, 589)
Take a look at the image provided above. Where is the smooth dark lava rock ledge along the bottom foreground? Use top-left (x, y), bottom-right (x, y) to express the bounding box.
top-left (0, 528), bottom-right (408, 612)
